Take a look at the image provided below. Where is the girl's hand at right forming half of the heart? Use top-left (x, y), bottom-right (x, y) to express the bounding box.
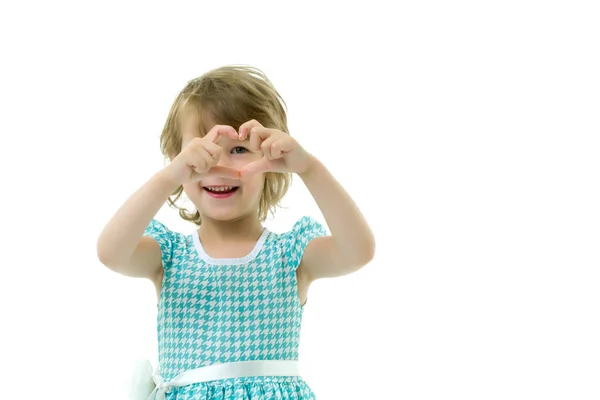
top-left (240, 120), bottom-right (313, 176)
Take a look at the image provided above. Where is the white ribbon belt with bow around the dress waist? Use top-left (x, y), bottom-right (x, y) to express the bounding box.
top-left (130, 360), bottom-right (300, 400)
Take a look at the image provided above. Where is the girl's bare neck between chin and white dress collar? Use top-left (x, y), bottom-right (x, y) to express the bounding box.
top-left (198, 217), bottom-right (263, 242)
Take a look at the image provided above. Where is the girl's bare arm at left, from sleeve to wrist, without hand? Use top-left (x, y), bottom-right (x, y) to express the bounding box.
top-left (97, 172), bottom-right (175, 280)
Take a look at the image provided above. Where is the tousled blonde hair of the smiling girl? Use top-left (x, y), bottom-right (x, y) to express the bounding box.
top-left (160, 66), bottom-right (292, 225)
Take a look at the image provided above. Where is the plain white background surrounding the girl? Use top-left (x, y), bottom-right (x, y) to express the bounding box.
top-left (0, 1), bottom-right (600, 400)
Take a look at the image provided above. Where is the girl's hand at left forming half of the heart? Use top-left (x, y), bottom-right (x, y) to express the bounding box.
top-left (164, 125), bottom-right (240, 186)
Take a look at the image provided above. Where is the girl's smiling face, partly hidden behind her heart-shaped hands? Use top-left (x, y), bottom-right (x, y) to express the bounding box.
top-left (182, 125), bottom-right (265, 221)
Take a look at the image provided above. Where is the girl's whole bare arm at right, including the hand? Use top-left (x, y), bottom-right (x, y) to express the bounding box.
top-left (234, 120), bottom-right (375, 284)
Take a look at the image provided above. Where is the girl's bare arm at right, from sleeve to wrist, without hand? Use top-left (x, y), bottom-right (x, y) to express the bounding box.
top-left (298, 158), bottom-right (375, 282)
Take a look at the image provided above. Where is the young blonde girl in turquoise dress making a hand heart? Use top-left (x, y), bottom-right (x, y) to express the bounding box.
top-left (98, 66), bottom-right (375, 400)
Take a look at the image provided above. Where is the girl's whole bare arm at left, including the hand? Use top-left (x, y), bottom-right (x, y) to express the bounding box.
top-left (97, 118), bottom-right (240, 282)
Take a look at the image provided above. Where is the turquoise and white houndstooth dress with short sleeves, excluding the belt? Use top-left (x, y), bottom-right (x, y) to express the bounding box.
top-left (144, 217), bottom-right (327, 400)
